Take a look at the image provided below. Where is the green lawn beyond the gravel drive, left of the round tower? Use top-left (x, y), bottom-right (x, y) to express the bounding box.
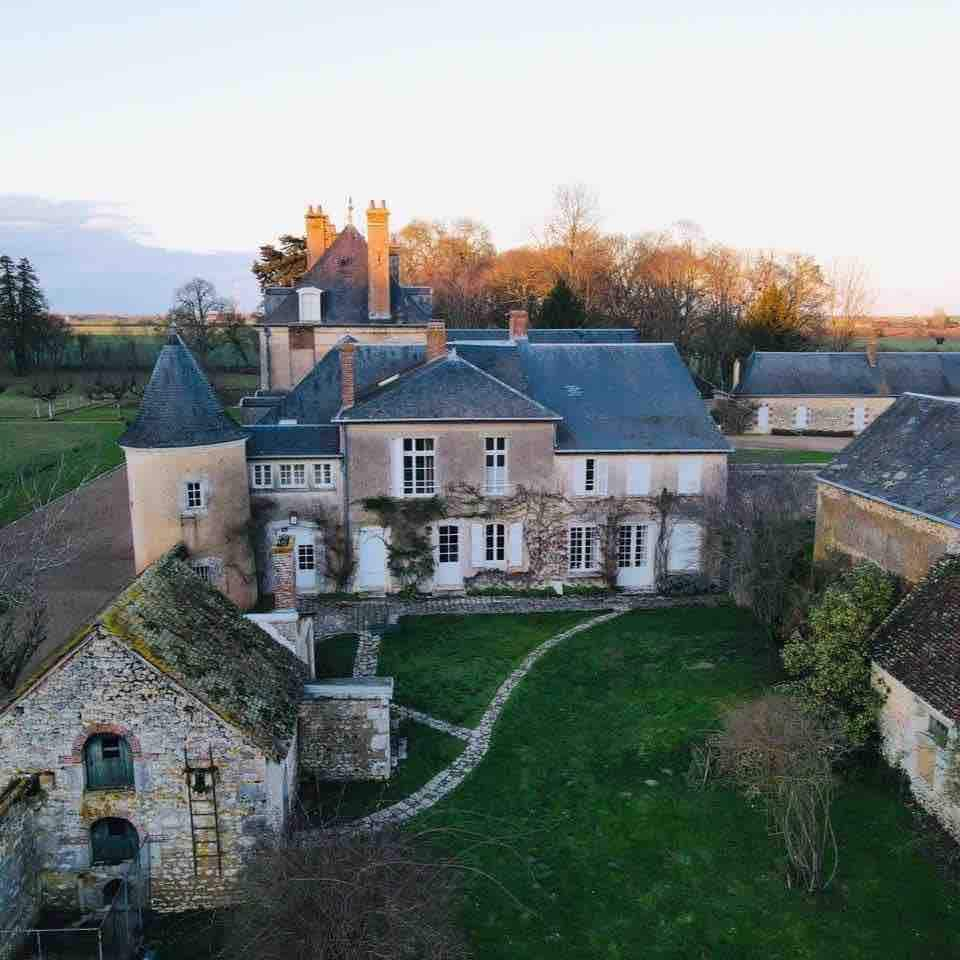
top-left (0, 420), bottom-right (126, 526)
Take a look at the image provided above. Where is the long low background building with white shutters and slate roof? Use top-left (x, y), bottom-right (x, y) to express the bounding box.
top-left (734, 340), bottom-right (960, 435)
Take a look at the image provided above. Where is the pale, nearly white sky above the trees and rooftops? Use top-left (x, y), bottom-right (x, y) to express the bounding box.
top-left (0, 0), bottom-right (960, 313)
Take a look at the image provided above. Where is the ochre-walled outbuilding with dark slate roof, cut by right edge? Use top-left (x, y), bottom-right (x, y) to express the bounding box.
top-left (816, 393), bottom-right (960, 583)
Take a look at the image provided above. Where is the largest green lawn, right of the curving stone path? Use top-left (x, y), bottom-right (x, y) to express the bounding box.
top-left (418, 607), bottom-right (960, 960)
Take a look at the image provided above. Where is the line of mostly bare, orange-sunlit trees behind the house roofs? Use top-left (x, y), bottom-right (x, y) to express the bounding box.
top-left (253, 185), bottom-right (884, 387)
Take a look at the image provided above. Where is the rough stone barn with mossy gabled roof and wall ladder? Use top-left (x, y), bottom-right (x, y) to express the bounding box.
top-left (0, 548), bottom-right (308, 911)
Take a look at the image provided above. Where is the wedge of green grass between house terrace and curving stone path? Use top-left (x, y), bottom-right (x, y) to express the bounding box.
top-left (378, 612), bottom-right (596, 726)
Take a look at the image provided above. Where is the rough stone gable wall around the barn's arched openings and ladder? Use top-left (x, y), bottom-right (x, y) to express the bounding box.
top-left (0, 631), bottom-right (296, 910)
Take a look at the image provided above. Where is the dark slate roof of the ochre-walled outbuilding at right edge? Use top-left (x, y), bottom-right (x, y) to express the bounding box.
top-left (817, 393), bottom-right (960, 527)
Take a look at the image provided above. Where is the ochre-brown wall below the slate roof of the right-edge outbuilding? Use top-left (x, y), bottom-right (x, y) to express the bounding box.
top-left (814, 483), bottom-right (960, 583)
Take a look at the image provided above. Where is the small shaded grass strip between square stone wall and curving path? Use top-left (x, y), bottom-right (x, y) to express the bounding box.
top-left (300, 721), bottom-right (466, 823)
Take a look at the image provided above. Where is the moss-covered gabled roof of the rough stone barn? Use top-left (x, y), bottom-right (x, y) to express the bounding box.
top-left (4, 547), bottom-right (308, 760)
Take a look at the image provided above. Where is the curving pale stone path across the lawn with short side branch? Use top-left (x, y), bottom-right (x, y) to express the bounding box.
top-left (297, 607), bottom-right (627, 843)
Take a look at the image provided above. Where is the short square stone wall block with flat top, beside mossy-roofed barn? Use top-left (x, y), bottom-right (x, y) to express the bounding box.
top-left (297, 677), bottom-right (393, 780)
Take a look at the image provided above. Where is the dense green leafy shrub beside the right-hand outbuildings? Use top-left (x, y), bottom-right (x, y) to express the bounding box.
top-left (782, 563), bottom-right (896, 746)
